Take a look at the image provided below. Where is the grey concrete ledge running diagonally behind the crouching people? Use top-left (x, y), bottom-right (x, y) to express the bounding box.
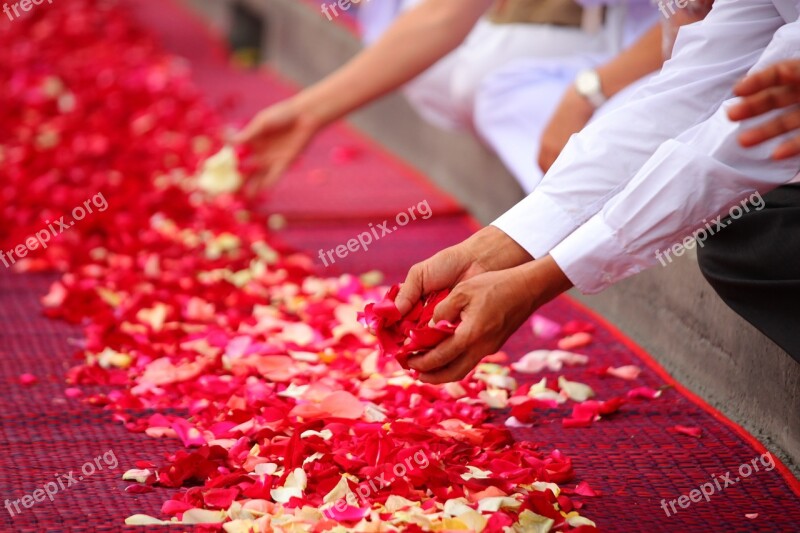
top-left (183, 0), bottom-right (800, 475)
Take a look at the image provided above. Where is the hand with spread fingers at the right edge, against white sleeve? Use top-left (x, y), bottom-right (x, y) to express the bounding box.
top-left (728, 59), bottom-right (800, 159)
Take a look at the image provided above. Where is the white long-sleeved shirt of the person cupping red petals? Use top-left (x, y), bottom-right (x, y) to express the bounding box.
top-left (493, 0), bottom-right (800, 293)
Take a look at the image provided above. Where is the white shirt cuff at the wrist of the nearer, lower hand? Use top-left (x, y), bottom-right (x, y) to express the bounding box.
top-left (550, 214), bottom-right (649, 294)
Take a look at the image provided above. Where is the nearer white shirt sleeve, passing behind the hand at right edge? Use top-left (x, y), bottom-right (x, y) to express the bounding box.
top-left (550, 20), bottom-right (800, 293)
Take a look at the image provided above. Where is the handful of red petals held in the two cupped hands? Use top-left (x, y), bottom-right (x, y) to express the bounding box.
top-left (359, 285), bottom-right (457, 369)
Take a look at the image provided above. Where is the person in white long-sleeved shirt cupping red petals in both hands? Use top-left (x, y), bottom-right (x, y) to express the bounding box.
top-left (396, 0), bottom-right (800, 383)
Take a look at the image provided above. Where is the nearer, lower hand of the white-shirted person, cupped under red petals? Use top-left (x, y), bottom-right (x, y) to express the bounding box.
top-left (409, 256), bottom-right (572, 383)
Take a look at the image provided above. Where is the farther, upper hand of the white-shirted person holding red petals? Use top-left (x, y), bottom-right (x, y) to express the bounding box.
top-left (395, 226), bottom-right (532, 315)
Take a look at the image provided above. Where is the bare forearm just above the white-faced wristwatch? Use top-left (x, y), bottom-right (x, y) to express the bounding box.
top-left (597, 24), bottom-right (664, 98)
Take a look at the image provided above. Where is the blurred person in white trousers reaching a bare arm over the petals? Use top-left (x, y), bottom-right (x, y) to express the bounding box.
top-left (234, 0), bottom-right (657, 191)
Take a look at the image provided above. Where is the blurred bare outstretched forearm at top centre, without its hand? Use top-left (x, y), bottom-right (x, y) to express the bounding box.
top-left (297, 0), bottom-right (491, 124)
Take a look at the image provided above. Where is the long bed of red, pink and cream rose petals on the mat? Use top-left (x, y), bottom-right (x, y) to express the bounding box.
top-left (0, 0), bottom-right (676, 532)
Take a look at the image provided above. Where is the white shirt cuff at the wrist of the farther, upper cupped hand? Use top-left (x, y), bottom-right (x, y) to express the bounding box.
top-left (492, 189), bottom-right (578, 259)
